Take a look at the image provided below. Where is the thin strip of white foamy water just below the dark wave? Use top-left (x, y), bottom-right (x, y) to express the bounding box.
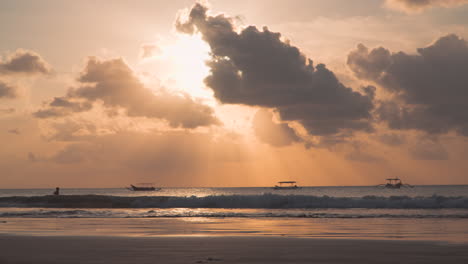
top-left (0, 208), bottom-right (468, 219)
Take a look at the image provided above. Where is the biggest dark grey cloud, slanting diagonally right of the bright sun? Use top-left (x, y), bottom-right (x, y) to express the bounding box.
top-left (176, 4), bottom-right (373, 136)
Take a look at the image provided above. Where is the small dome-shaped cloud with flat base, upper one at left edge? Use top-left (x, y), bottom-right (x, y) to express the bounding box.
top-left (0, 49), bottom-right (51, 75)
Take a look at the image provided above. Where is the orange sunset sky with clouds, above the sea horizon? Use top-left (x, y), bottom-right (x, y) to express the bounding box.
top-left (0, 0), bottom-right (468, 188)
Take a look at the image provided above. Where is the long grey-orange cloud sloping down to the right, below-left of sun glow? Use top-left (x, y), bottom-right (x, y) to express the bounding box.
top-left (34, 58), bottom-right (219, 128)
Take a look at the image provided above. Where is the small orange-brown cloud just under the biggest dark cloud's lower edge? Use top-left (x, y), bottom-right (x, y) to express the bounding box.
top-left (253, 109), bottom-right (302, 147)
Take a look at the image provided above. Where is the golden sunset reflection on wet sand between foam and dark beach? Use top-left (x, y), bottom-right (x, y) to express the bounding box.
top-left (0, 217), bottom-right (468, 243)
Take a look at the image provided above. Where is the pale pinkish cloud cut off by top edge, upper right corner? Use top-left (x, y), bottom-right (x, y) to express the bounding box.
top-left (385, 0), bottom-right (468, 13)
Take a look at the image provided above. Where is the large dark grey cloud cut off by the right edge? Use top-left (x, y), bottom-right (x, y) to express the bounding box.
top-left (348, 35), bottom-right (468, 135)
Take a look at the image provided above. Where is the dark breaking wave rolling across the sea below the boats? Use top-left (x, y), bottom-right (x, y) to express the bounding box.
top-left (0, 193), bottom-right (468, 209)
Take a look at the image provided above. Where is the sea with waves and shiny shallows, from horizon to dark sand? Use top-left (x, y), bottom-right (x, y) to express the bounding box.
top-left (0, 185), bottom-right (468, 244)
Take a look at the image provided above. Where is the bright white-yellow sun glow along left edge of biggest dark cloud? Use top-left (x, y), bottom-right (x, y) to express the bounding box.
top-left (140, 33), bottom-right (257, 138)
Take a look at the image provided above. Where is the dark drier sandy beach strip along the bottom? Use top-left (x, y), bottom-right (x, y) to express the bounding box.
top-left (0, 235), bottom-right (468, 264)
